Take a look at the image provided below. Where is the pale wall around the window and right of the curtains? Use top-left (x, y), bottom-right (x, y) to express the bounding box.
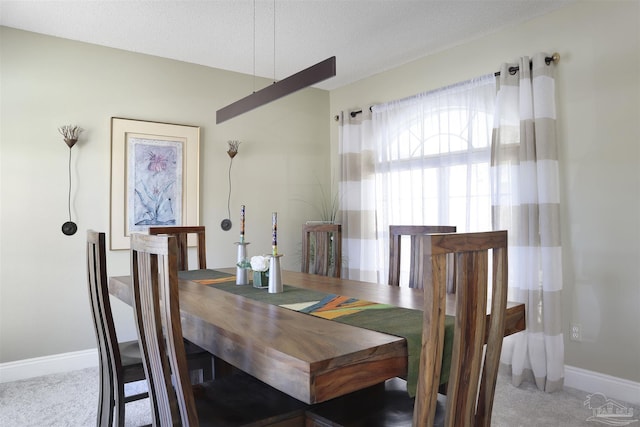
top-left (331, 1), bottom-right (640, 382)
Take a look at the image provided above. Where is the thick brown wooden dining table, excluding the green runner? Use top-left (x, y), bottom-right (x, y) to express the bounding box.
top-left (109, 268), bottom-right (525, 404)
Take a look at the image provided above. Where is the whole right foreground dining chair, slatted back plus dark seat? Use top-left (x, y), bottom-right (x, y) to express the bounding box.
top-left (306, 231), bottom-right (508, 427)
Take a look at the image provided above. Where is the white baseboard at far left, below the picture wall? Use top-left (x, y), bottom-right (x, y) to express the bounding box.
top-left (0, 348), bottom-right (98, 383)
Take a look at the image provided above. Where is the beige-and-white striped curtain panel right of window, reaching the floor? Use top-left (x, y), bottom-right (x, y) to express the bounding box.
top-left (491, 54), bottom-right (564, 392)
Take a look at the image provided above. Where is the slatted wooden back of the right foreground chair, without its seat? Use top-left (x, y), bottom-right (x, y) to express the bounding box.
top-left (413, 231), bottom-right (508, 427)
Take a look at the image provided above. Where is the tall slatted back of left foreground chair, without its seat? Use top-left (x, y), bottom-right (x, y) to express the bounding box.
top-left (131, 234), bottom-right (198, 426)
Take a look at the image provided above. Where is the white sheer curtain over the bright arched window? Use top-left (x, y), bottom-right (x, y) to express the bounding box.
top-left (372, 74), bottom-right (495, 285)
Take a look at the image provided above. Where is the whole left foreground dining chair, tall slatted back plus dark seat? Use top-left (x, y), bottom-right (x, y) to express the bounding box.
top-left (131, 234), bottom-right (307, 427)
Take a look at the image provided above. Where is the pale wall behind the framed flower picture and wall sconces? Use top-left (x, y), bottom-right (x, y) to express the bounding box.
top-left (0, 28), bottom-right (330, 362)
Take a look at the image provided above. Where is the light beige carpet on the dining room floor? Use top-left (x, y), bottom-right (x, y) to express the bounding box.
top-left (0, 368), bottom-right (640, 427)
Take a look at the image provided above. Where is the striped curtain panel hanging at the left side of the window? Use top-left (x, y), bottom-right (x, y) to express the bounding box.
top-left (338, 109), bottom-right (382, 283)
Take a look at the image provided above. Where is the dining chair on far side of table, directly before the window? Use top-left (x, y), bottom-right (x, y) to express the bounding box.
top-left (389, 225), bottom-right (456, 288)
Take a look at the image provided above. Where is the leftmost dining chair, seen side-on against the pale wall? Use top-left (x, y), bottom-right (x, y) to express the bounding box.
top-left (87, 230), bottom-right (148, 427)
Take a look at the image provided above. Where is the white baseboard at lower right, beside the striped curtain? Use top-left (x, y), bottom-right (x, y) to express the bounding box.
top-left (564, 365), bottom-right (640, 405)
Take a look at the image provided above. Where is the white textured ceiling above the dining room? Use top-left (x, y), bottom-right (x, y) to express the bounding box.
top-left (0, 0), bottom-right (576, 90)
